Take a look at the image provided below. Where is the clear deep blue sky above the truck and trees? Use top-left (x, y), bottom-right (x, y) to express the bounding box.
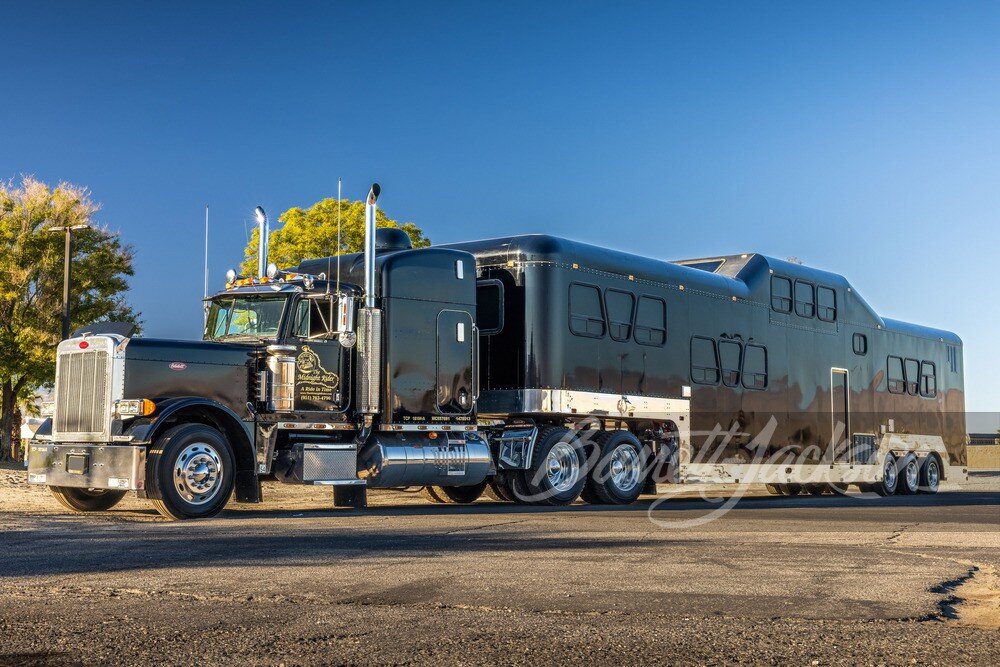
top-left (0, 1), bottom-right (1000, 410)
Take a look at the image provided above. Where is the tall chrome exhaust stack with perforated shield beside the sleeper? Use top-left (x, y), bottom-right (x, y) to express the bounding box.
top-left (358, 183), bottom-right (382, 420)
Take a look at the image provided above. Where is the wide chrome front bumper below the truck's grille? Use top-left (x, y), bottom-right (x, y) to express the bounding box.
top-left (28, 441), bottom-right (146, 491)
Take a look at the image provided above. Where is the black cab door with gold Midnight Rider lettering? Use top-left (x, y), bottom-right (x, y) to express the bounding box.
top-left (292, 295), bottom-right (350, 412)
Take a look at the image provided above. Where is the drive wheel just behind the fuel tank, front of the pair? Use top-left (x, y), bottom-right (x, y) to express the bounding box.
top-left (515, 426), bottom-right (587, 505)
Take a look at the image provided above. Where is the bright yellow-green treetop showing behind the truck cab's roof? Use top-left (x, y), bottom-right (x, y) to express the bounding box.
top-left (240, 198), bottom-right (431, 276)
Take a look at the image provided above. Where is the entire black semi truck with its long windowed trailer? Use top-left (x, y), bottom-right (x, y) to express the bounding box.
top-left (28, 186), bottom-right (965, 519)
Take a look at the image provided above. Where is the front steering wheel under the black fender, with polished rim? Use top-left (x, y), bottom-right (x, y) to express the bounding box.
top-left (148, 424), bottom-right (235, 521)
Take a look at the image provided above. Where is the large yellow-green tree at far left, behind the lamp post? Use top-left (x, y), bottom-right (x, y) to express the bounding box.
top-left (0, 177), bottom-right (138, 459)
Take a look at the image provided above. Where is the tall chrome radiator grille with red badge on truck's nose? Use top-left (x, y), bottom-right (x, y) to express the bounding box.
top-left (54, 349), bottom-right (111, 435)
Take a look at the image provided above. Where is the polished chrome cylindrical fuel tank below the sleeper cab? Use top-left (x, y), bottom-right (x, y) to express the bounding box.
top-left (358, 433), bottom-right (495, 488)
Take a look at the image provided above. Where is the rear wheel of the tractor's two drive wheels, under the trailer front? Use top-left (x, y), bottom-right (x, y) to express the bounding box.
top-left (584, 431), bottom-right (646, 505)
